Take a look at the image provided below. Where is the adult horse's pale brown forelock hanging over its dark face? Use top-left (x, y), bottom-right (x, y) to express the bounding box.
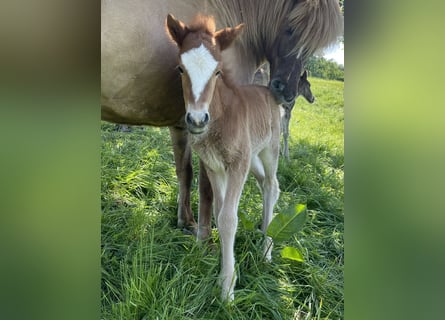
top-left (289, 0), bottom-right (343, 60)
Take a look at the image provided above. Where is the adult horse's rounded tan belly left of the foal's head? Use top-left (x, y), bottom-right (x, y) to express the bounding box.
top-left (101, 0), bottom-right (199, 126)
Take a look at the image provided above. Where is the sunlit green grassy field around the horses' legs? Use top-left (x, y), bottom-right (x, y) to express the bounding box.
top-left (101, 78), bottom-right (344, 320)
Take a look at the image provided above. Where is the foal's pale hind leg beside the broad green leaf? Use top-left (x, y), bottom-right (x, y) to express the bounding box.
top-left (259, 144), bottom-right (280, 261)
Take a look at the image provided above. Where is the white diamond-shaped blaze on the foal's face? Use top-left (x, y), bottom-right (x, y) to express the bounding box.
top-left (181, 44), bottom-right (218, 101)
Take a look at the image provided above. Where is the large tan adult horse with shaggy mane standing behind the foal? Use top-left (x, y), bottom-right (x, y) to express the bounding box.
top-left (101, 0), bottom-right (342, 239)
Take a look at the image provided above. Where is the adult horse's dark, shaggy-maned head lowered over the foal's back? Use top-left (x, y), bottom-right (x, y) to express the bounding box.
top-left (262, 0), bottom-right (343, 103)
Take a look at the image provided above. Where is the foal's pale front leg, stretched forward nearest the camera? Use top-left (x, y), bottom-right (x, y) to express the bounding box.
top-left (215, 163), bottom-right (248, 301)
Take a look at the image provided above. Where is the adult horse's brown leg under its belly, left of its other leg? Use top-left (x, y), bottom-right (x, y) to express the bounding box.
top-left (169, 127), bottom-right (196, 233)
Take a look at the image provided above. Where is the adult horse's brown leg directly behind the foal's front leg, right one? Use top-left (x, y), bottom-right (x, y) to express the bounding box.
top-left (197, 160), bottom-right (213, 241)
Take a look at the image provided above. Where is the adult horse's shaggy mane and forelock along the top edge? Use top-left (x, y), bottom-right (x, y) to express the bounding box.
top-left (211, 0), bottom-right (343, 60)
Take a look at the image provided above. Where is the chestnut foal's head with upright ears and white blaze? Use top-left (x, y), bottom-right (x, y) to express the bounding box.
top-left (166, 14), bottom-right (244, 134)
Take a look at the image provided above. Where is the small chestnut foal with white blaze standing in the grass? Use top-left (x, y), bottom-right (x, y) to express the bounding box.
top-left (167, 15), bottom-right (280, 301)
